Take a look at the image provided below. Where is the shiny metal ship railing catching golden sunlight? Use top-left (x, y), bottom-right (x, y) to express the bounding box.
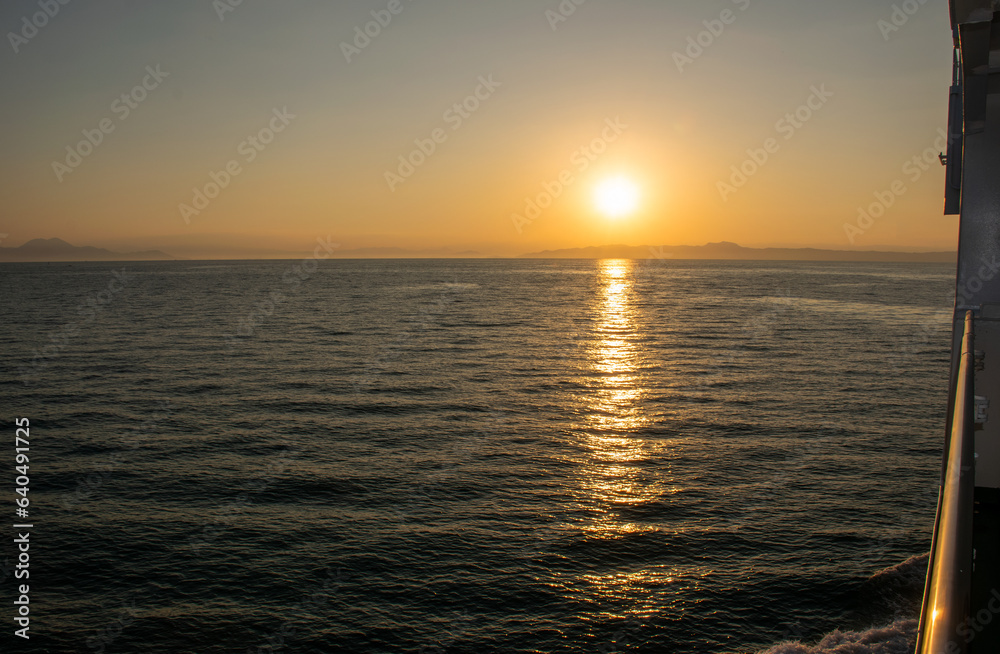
top-left (916, 311), bottom-right (976, 654)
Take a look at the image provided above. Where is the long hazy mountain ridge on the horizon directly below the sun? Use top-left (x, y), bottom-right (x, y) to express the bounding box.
top-left (519, 241), bottom-right (958, 263)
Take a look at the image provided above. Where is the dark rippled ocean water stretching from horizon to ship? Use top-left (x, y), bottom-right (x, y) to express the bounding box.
top-left (0, 260), bottom-right (954, 654)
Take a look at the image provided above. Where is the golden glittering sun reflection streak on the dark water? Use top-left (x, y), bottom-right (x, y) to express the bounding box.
top-left (565, 266), bottom-right (692, 623)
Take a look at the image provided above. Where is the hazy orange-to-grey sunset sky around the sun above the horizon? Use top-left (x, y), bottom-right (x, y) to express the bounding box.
top-left (0, 0), bottom-right (957, 256)
